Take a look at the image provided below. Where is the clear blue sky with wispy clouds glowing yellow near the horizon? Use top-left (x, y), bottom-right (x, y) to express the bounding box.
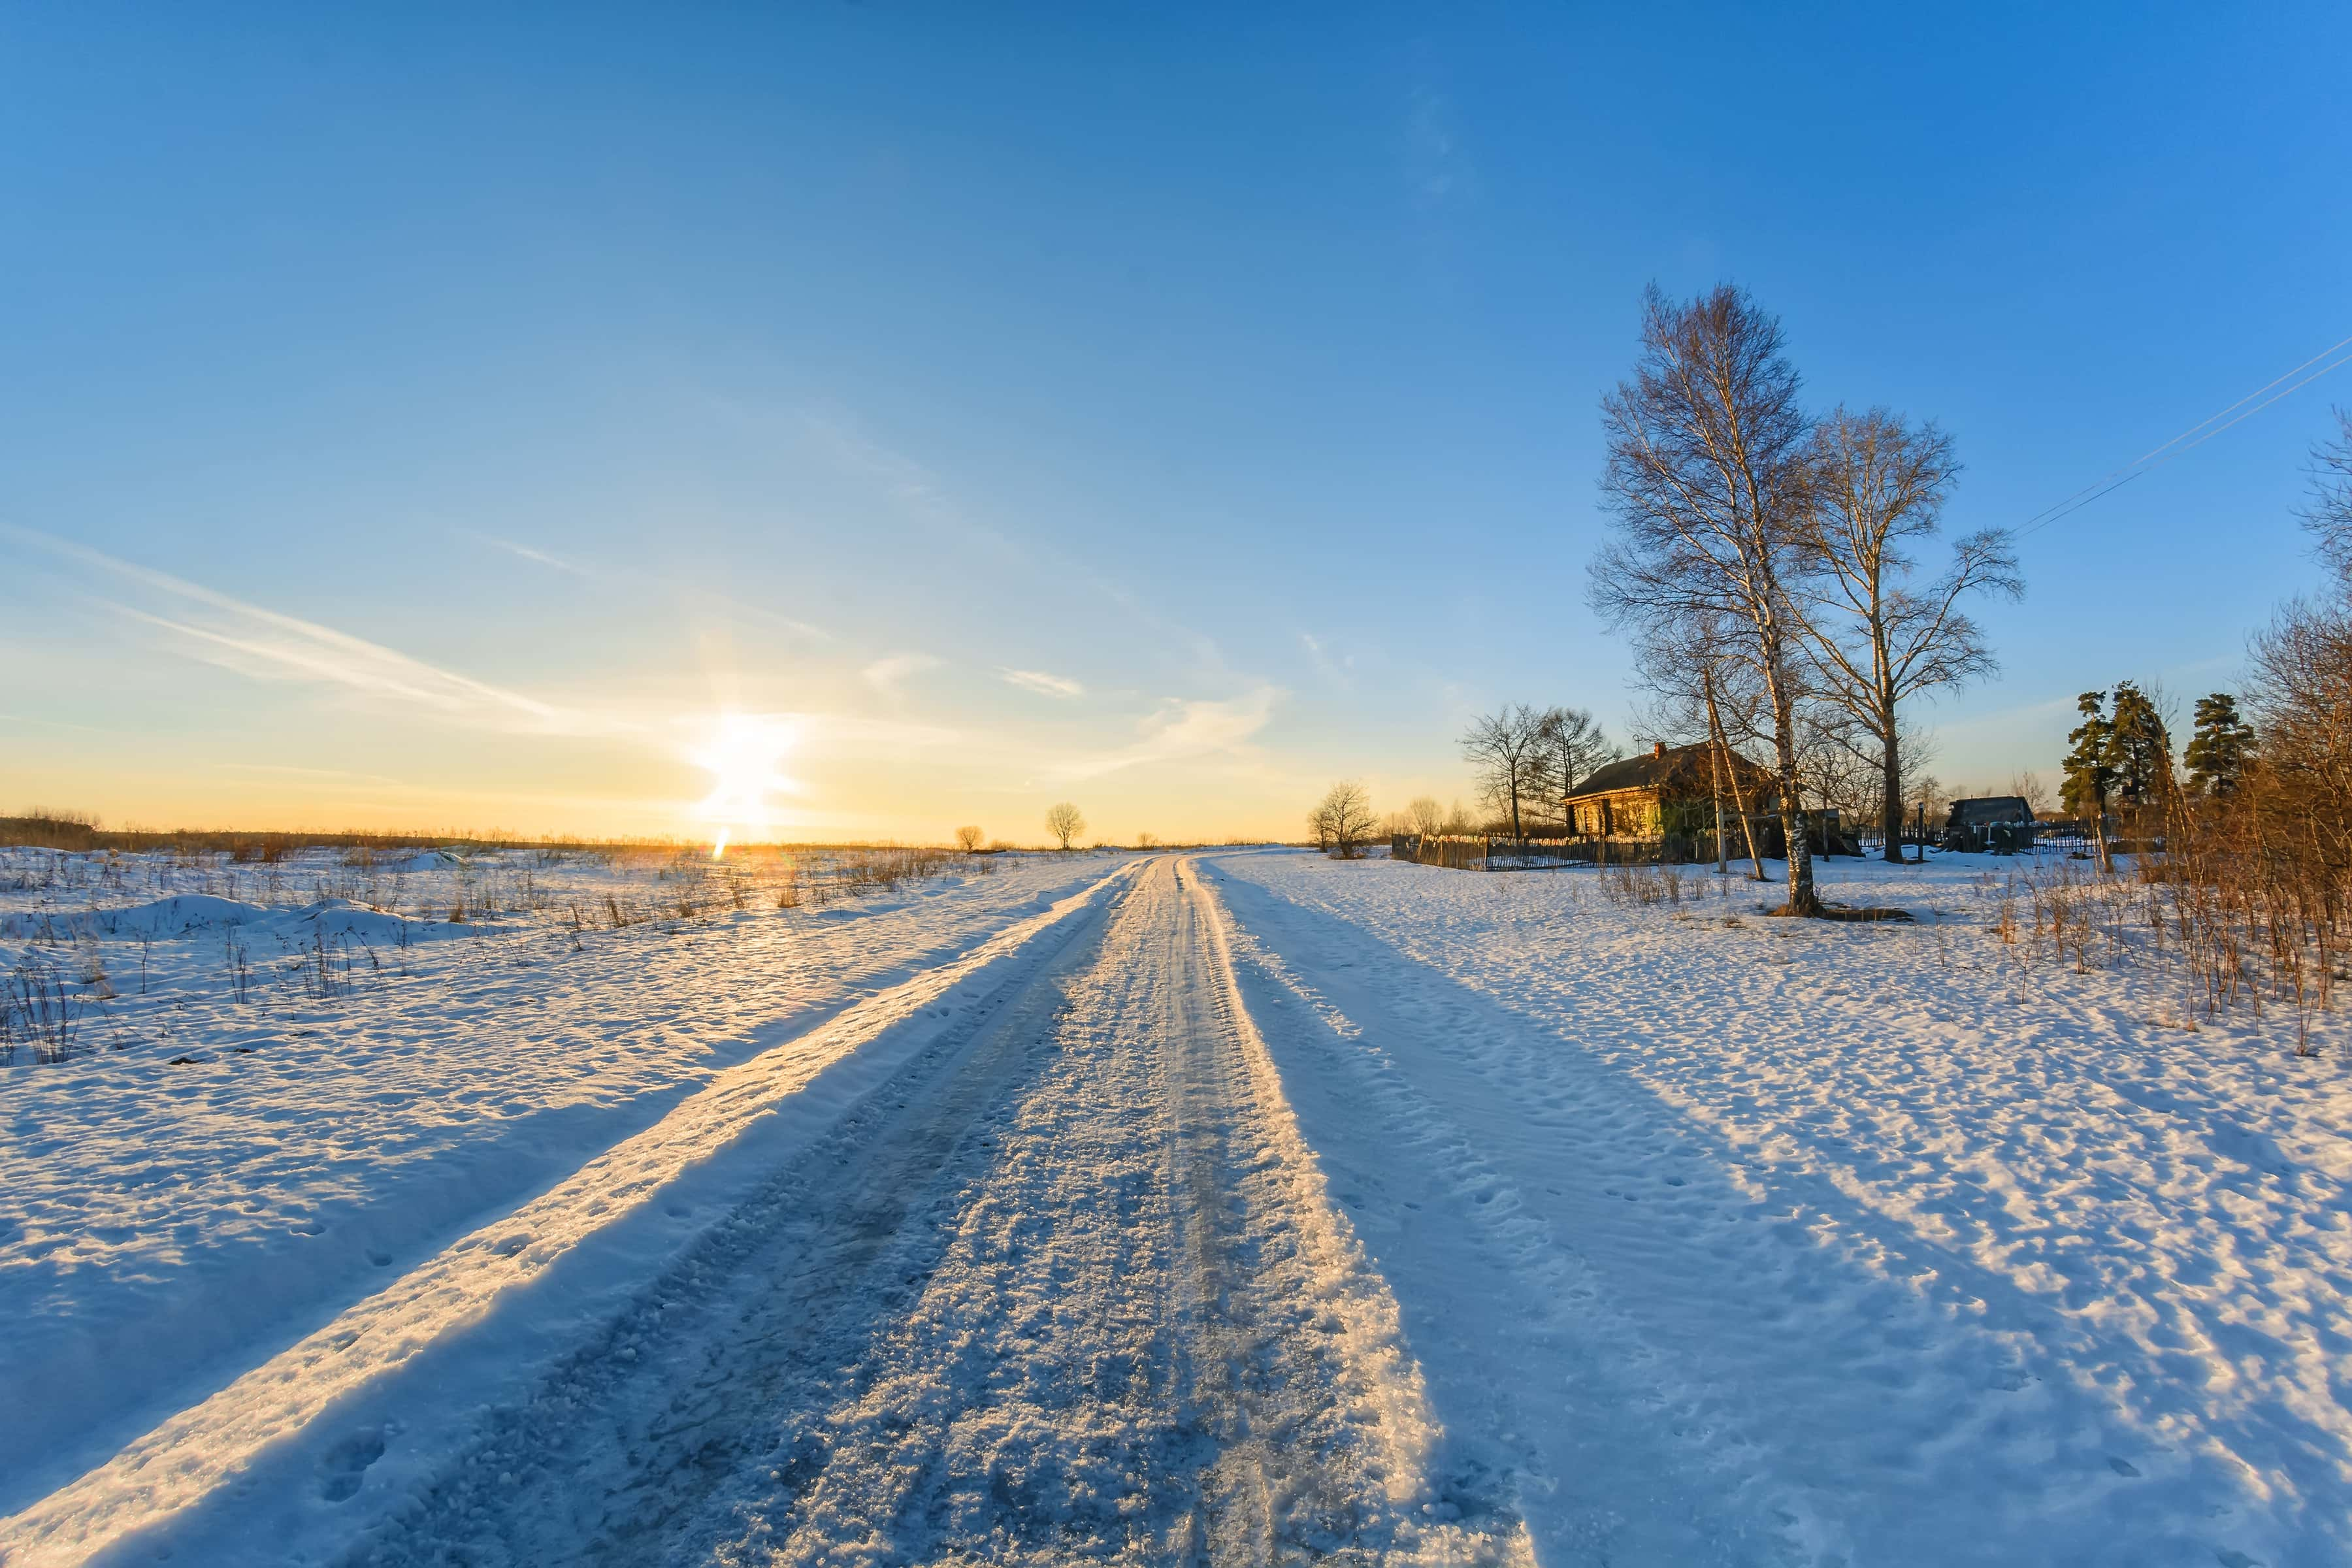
top-left (0, 3), bottom-right (2352, 840)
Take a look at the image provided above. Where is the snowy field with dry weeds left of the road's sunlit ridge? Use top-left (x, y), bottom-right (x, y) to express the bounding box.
top-left (0, 851), bottom-right (1110, 1512)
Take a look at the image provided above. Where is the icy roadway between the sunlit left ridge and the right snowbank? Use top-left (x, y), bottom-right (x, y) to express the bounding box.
top-left (350, 860), bottom-right (1526, 1568)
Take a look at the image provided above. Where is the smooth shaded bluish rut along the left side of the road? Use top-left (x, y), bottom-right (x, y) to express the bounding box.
top-left (344, 860), bottom-right (1147, 1568)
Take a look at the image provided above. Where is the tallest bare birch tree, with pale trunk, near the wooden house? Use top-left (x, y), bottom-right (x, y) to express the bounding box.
top-left (1592, 284), bottom-right (1820, 915)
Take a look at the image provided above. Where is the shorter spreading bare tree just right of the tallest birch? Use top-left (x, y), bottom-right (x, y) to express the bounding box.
top-left (1795, 406), bottom-right (2025, 860)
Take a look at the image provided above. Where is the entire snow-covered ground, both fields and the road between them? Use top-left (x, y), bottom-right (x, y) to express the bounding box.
top-left (0, 851), bottom-right (2352, 1568)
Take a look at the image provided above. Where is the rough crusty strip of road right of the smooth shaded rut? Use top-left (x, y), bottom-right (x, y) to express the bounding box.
top-left (691, 863), bottom-right (1524, 1563)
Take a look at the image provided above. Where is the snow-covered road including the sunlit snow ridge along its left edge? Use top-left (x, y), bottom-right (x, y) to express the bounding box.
top-left (0, 858), bottom-right (1529, 1563)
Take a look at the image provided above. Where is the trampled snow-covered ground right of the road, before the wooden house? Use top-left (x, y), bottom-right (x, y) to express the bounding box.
top-left (1209, 856), bottom-right (2352, 1568)
